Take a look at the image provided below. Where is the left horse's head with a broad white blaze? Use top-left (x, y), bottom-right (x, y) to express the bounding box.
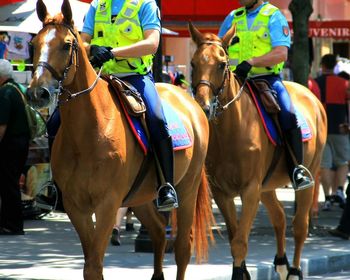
top-left (27, 0), bottom-right (78, 108)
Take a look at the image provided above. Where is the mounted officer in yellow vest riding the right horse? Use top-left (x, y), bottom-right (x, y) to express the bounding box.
top-left (219, 0), bottom-right (313, 191)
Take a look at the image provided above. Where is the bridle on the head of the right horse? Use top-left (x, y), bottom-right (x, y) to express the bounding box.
top-left (192, 41), bottom-right (246, 120)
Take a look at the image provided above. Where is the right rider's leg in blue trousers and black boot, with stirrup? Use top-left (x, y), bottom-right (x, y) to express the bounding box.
top-left (268, 75), bottom-right (314, 191)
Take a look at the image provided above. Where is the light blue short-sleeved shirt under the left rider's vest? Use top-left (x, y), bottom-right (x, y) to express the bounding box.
top-left (82, 0), bottom-right (161, 36)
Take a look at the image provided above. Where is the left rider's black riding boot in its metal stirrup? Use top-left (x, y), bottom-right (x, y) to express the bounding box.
top-left (154, 136), bottom-right (178, 211)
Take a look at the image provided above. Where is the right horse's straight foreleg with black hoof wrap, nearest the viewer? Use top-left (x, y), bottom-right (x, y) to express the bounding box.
top-left (231, 182), bottom-right (260, 280)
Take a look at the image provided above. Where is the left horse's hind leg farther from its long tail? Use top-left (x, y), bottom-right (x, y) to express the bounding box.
top-left (132, 202), bottom-right (166, 280)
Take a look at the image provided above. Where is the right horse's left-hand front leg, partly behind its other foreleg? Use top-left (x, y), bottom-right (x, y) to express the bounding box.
top-left (212, 186), bottom-right (237, 243)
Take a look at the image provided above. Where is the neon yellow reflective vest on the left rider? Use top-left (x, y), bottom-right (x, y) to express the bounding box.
top-left (91, 0), bottom-right (153, 74)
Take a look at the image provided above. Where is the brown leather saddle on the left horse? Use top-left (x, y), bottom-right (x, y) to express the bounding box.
top-left (101, 74), bottom-right (146, 117)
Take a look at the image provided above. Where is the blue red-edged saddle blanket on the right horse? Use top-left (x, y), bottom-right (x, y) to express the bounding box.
top-left (251, 91), bottom-right (312, 146)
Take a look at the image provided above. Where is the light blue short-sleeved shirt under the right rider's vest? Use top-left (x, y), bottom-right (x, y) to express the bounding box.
top-left (218, 2), bottom-right (290, 48)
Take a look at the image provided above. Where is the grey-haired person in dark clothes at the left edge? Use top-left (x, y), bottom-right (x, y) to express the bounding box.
top-left (0, 59), bottom-right (30, 235)
